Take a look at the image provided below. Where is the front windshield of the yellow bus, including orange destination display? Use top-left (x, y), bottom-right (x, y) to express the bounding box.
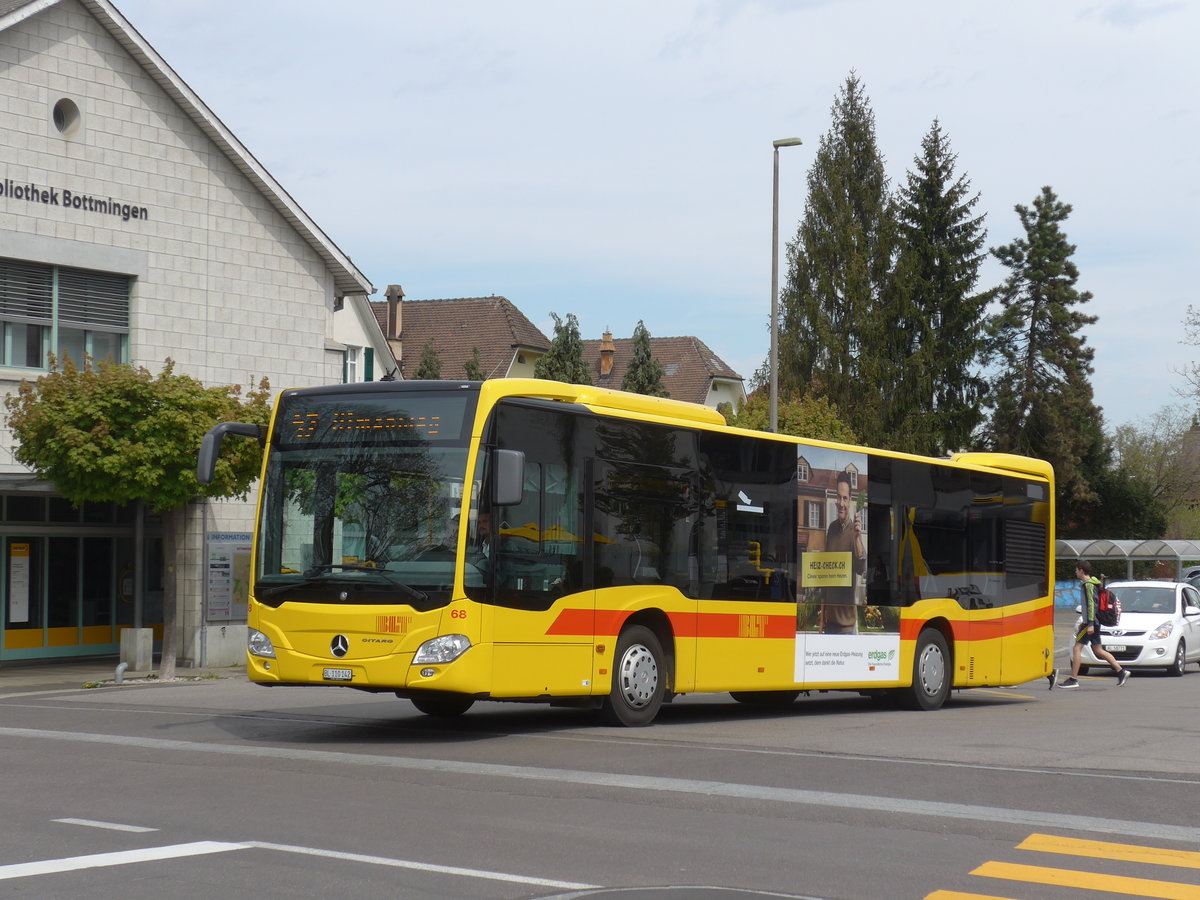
top-left (254, 392), bottom-right (474, 608)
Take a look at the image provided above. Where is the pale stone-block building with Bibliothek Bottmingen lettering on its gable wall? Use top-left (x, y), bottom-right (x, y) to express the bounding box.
top-left (0, 0), bottom-right (384, 666)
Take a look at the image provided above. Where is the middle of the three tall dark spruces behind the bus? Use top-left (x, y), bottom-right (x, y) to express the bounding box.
top-left (889, 119), bottom-right (994, 456)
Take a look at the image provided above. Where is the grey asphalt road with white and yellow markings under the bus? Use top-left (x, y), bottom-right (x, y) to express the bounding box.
top-left (0, 638), bottom-right (1200, 900)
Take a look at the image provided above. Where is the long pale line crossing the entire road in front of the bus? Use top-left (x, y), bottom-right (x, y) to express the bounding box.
top-left (0, 727), bottom-right (1200, 844)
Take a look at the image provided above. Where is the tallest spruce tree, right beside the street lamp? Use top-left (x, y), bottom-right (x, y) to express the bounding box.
top-left (779, 72), bottom-right (905, 444)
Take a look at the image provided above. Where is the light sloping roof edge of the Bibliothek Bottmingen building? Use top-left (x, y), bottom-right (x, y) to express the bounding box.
top-left (0, 0), bottom-right (374, 294)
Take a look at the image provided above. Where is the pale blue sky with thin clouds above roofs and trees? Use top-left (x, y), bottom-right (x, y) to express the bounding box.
top-left (108, 0), bottom-right (1200, 427)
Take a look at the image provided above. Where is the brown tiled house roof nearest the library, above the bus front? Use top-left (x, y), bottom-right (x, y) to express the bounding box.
top-left (371, 296), bottom-right (550, 379)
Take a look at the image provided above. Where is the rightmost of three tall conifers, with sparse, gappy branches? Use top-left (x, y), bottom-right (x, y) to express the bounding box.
top-left (988, 187), bottom-right (1111, 528)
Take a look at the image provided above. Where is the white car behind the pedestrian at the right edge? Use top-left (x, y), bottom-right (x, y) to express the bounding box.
top-left (1076, 581), bottom-right (1200, 676)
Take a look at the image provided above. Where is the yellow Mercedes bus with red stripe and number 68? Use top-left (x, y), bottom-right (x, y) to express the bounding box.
top-left (198, 379), bottom-right (1054, 726)
